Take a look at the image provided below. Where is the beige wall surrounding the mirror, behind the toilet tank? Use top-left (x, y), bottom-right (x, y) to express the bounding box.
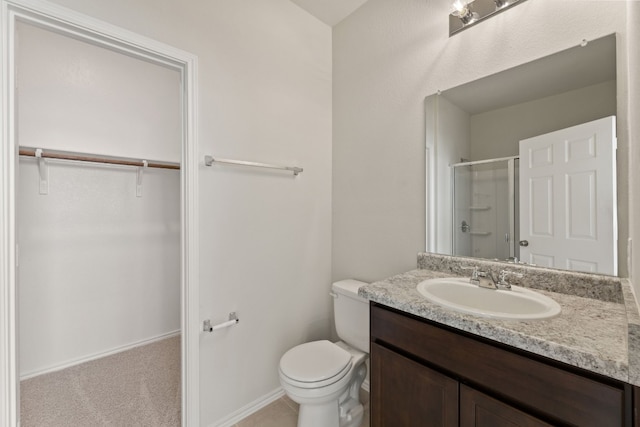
top-left (332, 0), bottom-right (638, 280)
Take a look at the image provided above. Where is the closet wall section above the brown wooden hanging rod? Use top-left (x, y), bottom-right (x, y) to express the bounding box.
top-left (16, 23), bottom-right (182, 162)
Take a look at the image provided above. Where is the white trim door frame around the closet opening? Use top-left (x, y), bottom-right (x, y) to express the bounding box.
top-left (0, 0), bottom-right (200, 426)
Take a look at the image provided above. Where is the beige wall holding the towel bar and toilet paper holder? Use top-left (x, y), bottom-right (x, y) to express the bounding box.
top-left (35, 0), bottom-right (332, 426)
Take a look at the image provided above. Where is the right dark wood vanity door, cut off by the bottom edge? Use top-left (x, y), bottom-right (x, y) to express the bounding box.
top-left (460, 384), bottom-right (551, 427)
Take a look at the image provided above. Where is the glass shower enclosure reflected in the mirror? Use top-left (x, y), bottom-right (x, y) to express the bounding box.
top-left (451, 156), bottom-right (519, 260)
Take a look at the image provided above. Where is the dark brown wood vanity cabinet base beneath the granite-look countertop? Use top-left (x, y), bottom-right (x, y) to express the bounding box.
top-left (371, 303), bottom-right (640, 427)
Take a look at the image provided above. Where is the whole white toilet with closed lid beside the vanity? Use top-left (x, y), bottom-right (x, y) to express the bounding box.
top-left (279, 280), bottom-right (369, 427)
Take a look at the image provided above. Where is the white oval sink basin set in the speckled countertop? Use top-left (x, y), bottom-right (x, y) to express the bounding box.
top-left (417, 277), bottom-right (560, 320)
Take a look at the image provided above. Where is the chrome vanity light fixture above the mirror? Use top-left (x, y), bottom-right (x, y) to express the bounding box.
top-left (449, 0), bottom-right (525, 36)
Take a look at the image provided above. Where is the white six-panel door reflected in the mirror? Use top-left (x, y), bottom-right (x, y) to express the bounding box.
top-left (520, 116), bottom-right (618, 275)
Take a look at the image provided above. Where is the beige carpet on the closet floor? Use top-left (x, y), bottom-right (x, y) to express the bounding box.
top-left (20, 336), bottom-right (180, 427)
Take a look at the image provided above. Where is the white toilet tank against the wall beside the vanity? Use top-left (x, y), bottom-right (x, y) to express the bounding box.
top-left (332, 279), bottom-right (369, 353)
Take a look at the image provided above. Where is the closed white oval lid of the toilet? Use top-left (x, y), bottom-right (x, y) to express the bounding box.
top-left (280, 340), bottom-right (351, 382)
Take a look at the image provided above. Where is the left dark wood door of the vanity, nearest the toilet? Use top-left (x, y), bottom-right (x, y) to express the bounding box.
top-left (371, 343), bottom-right (458, 427)
